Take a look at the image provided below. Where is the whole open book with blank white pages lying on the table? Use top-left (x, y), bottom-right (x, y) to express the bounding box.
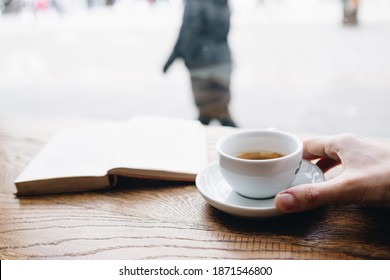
top-left (15, 116), bottom-right (232, 195)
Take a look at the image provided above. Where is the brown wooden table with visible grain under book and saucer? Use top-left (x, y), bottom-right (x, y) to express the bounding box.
top-left (0, 118), bottom-right (390, 260)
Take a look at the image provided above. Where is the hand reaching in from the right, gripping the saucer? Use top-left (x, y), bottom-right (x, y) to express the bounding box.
top-left (275, 134), bottom-right (390, 212)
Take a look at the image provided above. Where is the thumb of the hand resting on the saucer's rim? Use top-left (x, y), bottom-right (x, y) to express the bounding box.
top-left (275, 179), bottom-right (340, 213)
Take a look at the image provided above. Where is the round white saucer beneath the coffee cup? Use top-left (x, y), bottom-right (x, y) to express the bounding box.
top-left (196, 160), bottom-right (325, 219)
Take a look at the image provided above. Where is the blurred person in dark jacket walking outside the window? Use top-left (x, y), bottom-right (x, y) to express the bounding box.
top-left (163, 0), bottom-right (237, 127)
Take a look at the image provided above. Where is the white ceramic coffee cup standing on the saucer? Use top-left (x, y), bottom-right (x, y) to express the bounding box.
top-left (217, 129), bottom-right (303, 199)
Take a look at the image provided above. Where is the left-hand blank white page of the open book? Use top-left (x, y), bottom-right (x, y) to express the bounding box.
top-left (16, 123), bottom-right (124, 183)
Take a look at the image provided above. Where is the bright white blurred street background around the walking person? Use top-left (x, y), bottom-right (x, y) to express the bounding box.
top-left (0, 0), bottom-right (390, 137)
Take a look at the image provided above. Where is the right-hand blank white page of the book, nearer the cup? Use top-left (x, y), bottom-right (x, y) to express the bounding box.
top-left (111, 116), bottom-right (207, 175)
